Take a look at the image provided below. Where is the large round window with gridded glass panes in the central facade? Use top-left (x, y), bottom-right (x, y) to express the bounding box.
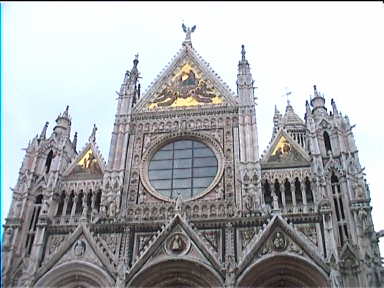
top-left (148, 140), bottom-right (218, 199)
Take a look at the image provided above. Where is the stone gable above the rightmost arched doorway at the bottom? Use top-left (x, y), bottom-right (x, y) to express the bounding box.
top-left (237, 215), bottom-right (329, 275)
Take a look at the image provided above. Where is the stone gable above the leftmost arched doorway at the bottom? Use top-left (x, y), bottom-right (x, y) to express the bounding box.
top-left (36, 223), bottom-right (116, 279)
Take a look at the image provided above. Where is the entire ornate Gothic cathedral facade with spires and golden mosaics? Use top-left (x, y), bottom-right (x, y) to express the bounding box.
top-left (2, 25), bottom-right (384, 288)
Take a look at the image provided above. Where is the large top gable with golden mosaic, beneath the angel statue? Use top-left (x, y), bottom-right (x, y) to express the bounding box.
top-left (134, 45), bottom-right (236, 112)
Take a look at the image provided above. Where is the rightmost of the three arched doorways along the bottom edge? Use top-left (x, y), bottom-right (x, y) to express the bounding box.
top-left (238, 256), bottom-right (328, 288)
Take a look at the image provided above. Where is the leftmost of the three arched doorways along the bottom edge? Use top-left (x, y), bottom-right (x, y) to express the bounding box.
top-left (34, 261), bottom-right (114, 288)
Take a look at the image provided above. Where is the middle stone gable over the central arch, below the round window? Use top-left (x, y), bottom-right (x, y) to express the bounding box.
top-left (128, 213), bottom-right (222, 278)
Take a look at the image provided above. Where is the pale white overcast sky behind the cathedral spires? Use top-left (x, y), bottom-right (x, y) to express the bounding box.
top-left (1, 1), bottom-right (384, 256)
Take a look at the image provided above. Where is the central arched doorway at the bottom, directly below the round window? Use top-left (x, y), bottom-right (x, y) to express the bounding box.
top-left (126, 259), bottom-right (223, 288)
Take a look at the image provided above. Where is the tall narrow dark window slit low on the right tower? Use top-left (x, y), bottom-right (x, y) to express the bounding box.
top-left (331, 172), bottom-right (348, 246)
